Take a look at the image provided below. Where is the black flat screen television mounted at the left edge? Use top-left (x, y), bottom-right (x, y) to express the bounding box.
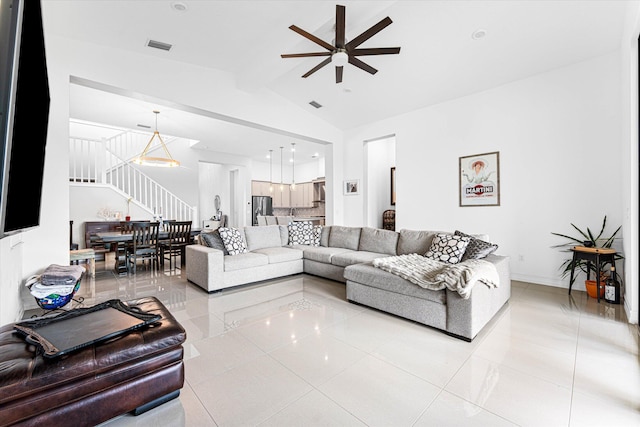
top-left (0, 0), bottom-right (50, 238)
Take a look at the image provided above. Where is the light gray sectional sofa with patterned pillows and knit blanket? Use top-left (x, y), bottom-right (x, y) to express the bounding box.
top-left (186, 225), bottom-right (511, 341)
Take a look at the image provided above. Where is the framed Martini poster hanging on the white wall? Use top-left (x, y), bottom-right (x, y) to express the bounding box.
top-left (459, 151), bottom-right (500, 207)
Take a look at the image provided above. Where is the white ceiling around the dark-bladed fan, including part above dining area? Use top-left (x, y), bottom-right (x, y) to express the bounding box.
top-left (43, 0), bottom-right (628, 164)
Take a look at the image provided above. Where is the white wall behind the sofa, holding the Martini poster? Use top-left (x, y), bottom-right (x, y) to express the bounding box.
top-left (344, 53), bottom-right (626, 296)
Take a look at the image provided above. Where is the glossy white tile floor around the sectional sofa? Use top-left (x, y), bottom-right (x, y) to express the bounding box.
top-left (33, 263), bottom-right (640, 427)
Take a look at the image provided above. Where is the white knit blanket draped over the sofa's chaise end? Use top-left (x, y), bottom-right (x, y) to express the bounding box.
top-left (373, 254), bottom-right (500, 299)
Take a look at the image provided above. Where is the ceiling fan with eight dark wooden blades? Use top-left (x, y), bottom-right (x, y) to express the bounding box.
top-left (280, 5), bottom-right (400, 83)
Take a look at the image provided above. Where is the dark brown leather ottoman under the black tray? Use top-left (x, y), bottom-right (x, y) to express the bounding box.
top-left (0, 297), bottom-right (186, 426)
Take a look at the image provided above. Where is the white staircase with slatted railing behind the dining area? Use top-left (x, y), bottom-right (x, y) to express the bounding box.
top-left (69, 131), bottom-right (196, 221)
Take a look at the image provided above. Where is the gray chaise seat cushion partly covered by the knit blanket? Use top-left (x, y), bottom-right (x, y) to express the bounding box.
top-left (344, 263), bottom-right (447, 304)
